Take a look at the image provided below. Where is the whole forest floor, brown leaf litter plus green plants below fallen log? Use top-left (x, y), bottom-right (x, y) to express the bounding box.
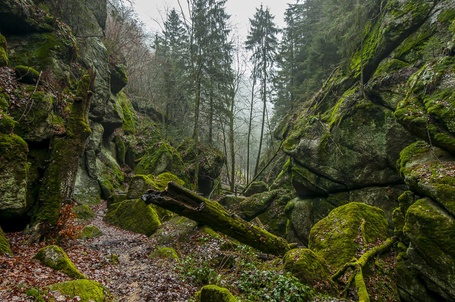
top-left (0, 202), bottom-right (341, 302)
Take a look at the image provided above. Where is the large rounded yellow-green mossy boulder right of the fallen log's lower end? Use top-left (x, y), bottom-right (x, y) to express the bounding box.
top-left (309, 202), bottom-right (389, 269)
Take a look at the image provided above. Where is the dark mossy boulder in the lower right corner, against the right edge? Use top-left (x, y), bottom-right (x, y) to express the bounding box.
top-left (403, 198), bottom-right (455, 301)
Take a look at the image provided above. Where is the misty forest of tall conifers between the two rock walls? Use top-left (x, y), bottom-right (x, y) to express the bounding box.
top-left (105, 0), bottom-right (383, 190)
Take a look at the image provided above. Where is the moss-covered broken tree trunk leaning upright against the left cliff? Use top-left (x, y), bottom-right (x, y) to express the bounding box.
top-left (33, 68), bottom-right (96, 240)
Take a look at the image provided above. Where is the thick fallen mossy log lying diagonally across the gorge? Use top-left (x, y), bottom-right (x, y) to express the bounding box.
top-left (142, 182), bottom-right (291, 256)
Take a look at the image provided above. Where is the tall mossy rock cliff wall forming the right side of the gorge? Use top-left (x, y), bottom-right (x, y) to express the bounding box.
top-left (277, 0), bottom-right (455, 301)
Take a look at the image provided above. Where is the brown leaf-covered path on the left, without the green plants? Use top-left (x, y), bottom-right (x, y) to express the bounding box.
top-left (0, 203), bottom-right (198, 301)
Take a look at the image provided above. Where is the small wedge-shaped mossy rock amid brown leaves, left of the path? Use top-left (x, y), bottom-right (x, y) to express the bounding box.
top-left (33, 245), bottom-right (85, 279)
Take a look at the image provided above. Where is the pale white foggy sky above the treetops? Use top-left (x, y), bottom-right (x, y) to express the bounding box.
top-left (134, 0), bottom-right (288, 39)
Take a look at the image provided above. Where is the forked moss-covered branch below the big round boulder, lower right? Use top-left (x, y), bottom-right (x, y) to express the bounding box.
top-left (331, 237), bottom-right (397, 302)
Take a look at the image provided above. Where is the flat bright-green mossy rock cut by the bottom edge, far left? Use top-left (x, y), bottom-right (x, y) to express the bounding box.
top-left (47, 280), bottom-right (106, 302)
